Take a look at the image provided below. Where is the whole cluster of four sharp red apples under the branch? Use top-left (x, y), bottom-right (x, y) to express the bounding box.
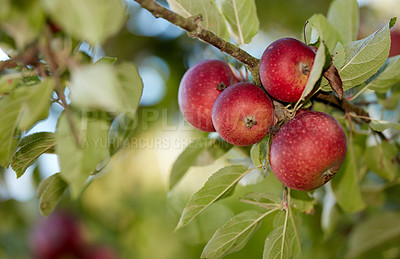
top-left (178, 38), bottom-right (347, 191)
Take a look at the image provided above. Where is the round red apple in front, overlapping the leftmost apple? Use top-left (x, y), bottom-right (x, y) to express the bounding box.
top-left (212, 82), bottom-right (274, 146)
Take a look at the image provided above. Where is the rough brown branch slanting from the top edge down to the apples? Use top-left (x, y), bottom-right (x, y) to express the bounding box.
top-left (135, 0), bottom-right (261, 86)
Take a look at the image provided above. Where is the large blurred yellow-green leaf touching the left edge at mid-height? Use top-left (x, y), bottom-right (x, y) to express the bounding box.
top-left (0, 79), bottom-right (53, 167)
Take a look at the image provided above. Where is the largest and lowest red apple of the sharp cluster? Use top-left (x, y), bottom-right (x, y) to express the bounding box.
top-left (270, 111), bottom-right (347, 191)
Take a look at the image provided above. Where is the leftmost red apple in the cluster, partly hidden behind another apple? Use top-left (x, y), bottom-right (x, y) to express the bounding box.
top-left (178, 60), bottom-right (235, 132)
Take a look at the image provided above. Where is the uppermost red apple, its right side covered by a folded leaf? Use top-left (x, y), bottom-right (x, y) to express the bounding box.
top-left (260, 38), bottom-right (315, 102)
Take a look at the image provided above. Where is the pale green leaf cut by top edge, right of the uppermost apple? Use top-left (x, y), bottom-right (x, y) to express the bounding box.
top-left (327, 0), bottom-right (359, 43)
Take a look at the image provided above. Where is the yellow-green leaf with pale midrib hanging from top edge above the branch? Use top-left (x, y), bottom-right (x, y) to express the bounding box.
top-left (220, 0), bottom-right (260, 45)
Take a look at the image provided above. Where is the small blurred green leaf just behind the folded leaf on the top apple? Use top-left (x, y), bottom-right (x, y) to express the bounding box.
top-left (308, 14), bottom-right (342, 52)
